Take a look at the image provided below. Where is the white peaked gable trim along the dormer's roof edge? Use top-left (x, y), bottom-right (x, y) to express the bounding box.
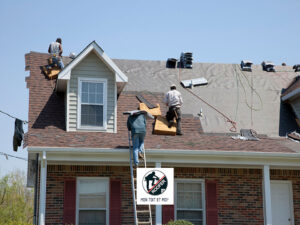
top-left (56, 41), bottom-right (128, 91)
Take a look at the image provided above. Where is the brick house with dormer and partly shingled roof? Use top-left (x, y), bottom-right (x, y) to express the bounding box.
top-left (25, 42), bottom-right (300, 225)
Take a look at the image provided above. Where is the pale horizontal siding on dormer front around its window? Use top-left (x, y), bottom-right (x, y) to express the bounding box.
top-left (68, 52), bottom-right (116, 132)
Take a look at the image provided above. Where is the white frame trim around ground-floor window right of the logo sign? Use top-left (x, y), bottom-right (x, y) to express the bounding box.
top-left (174, 178), bottom-right (206, 225)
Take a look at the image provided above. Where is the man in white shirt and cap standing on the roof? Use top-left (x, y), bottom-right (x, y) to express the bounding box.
top-left (164, 84), bottom-right (183, 135)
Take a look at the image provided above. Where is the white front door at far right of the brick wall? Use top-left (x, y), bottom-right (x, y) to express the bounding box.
top-left (271, 180), bottom-right (294, 225)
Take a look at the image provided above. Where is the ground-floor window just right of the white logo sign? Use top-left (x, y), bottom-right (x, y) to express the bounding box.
top-left (175, 180), bottom-right (205, 225)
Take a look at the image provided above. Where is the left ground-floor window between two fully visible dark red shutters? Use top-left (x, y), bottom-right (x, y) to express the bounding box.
top-left (76, 178), bottom-right (109, 225)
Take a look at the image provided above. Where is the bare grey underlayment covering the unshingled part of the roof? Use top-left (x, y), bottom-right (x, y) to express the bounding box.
top-left (114, 60), bottom-right (297, 136)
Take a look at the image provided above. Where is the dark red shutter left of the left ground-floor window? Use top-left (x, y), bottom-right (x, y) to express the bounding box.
top-left (63, 180), bottom-right (76, 224)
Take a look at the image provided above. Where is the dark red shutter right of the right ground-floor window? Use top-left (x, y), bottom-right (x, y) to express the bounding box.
top-left (206, 181), bottom-right (218, 225)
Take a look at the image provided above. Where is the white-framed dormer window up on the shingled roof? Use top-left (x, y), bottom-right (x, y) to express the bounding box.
top-left (77, 78), bottom-right (107, 130)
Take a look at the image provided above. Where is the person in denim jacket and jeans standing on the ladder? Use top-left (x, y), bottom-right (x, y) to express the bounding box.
top-left (127, 113), bottom-right (146, 167)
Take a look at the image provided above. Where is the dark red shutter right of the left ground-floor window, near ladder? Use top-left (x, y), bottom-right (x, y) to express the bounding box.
top-left (109, 180), bottom-right (122, 225)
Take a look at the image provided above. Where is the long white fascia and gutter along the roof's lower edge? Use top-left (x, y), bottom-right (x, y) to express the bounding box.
top-left (28, 147), bottom-right (300, 168)
